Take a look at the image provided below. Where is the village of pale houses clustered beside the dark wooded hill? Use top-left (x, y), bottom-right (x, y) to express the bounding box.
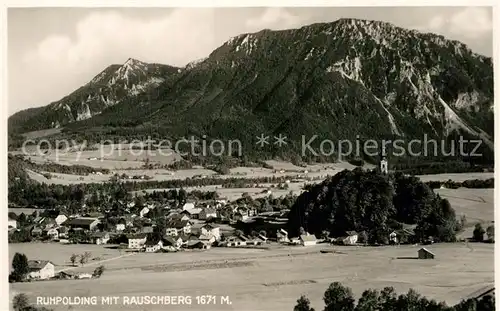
top-left (8, 190), bottom-right (448, 281)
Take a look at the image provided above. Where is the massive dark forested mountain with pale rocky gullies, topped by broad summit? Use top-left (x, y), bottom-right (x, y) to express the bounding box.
top-left (9, 19), bottom-right (494, 161)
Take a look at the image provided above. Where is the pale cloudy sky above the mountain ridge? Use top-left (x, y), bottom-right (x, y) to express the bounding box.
top-left (7, 7), bottom-right (493, 115)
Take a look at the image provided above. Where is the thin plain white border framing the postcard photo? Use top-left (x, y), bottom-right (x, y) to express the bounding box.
top-left (0, 0), bottom-right (500, 310)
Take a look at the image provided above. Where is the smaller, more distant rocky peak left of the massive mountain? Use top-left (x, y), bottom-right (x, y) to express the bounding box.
top-left (9, 58), bottom-right (179, 131)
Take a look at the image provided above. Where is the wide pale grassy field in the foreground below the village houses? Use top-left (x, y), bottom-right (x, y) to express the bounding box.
top-left (11, 243), bottom-right (494, 311)
